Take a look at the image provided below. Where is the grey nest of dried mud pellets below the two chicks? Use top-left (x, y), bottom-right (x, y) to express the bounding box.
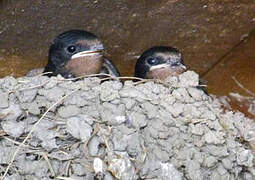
top-left (0, 71), bottom-right (255, 180)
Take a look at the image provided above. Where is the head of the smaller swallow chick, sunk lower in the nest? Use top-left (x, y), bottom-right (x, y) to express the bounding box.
top-left (135, 46), bottom-right (186, 80)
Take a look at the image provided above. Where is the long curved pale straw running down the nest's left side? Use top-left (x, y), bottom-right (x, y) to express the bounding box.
top-left (1, 89), bottom-right (78, 180)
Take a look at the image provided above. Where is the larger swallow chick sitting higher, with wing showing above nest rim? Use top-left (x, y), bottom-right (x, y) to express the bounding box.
top-left (27, 29), bottom-right (120, 78)
